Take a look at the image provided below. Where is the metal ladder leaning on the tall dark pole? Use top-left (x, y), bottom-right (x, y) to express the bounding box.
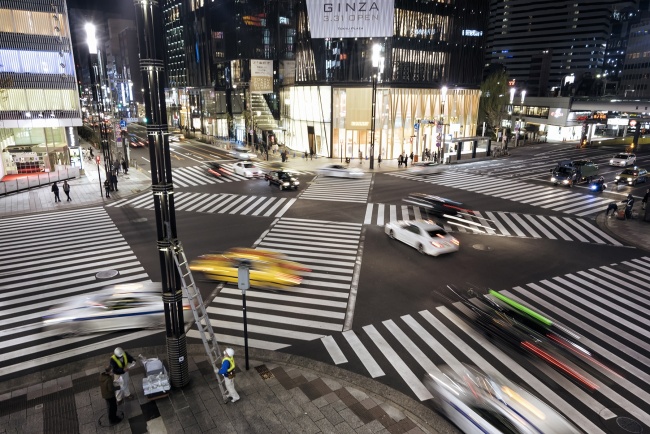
top-left (171, 241), bottom-right (228, 402)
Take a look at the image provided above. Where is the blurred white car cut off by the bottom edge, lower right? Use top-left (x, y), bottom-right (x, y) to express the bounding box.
top-left (423, 365), bottom-right (581, 434)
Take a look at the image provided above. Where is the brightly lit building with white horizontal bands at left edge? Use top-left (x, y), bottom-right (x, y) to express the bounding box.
top-left (0, 0), bottom-right (81, 178)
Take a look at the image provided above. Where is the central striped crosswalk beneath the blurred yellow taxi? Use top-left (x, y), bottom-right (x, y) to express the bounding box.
top-left (188, 218), bottom-right (362, 350)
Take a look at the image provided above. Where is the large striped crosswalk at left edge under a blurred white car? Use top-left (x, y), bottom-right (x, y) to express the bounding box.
top-left (0, 207), bottom-right (154, 379)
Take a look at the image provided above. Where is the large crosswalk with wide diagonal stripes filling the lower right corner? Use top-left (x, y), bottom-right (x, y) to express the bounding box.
top-left (320, 257), bottom-right (650, 433)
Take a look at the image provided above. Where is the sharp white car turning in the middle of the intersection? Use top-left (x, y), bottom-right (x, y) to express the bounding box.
top-left (384, 220), bottom-right (460, 256)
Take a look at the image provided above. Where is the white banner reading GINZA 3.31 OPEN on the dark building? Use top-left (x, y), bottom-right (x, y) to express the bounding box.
top-left (307, 0), bottom-right (395, 38)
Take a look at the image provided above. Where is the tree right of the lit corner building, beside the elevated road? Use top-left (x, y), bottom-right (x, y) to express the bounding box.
top-left (478, 71), bottom-right (510, 138)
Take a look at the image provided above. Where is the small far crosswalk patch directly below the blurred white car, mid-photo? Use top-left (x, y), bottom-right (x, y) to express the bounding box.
top-left (300, 177), bottom-right (372, 203)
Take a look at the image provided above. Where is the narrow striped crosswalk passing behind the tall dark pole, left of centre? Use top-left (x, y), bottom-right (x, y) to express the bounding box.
top-left (106, 191), bottom-right (296, 217)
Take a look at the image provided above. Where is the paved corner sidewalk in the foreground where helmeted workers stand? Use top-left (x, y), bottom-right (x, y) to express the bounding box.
top-left (0, 345), bottom-right (450, 434)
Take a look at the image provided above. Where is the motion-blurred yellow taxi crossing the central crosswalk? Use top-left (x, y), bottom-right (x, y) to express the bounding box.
top-left (190, 249), bottom-right (310, 289)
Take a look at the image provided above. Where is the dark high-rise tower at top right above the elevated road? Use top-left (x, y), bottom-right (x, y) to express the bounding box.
top-left (486, 0), bottom-right (638, 96)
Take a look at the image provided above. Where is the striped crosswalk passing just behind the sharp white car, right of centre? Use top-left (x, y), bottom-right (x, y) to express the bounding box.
top-left (363, 203), bottom-right (622, 246)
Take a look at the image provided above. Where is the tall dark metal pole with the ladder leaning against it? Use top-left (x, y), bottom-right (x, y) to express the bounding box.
top-left (135, 0), bottom-right (190, 387)
